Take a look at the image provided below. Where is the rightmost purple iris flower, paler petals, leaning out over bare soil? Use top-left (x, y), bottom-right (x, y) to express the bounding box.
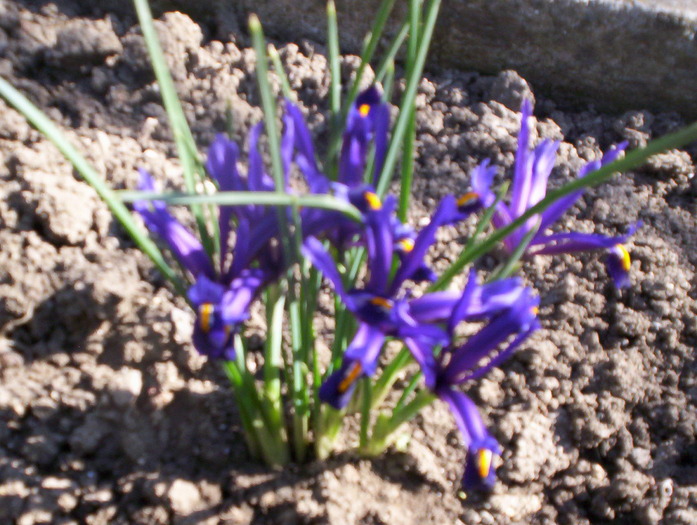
top-left (468, 100), bottom-right (639, 288)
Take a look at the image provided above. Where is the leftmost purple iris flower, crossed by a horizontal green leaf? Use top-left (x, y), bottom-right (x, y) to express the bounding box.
top-left (134, 125), bottom-right (283, 359)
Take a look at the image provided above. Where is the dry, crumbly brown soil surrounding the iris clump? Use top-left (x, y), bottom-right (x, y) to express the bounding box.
top-left (0, 0), bottom-right (697, 525)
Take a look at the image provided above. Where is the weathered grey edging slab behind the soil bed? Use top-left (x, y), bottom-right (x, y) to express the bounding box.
top-left (141, 0), bottom-right (697, 117)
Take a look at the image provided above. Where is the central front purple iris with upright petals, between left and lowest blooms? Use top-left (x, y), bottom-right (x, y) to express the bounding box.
top-left (303, 196), bottom-right (458, 408)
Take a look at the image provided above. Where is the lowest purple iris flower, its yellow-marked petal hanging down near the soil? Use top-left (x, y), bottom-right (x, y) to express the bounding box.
top-left (419, 272), bottom-right (539, 489)
